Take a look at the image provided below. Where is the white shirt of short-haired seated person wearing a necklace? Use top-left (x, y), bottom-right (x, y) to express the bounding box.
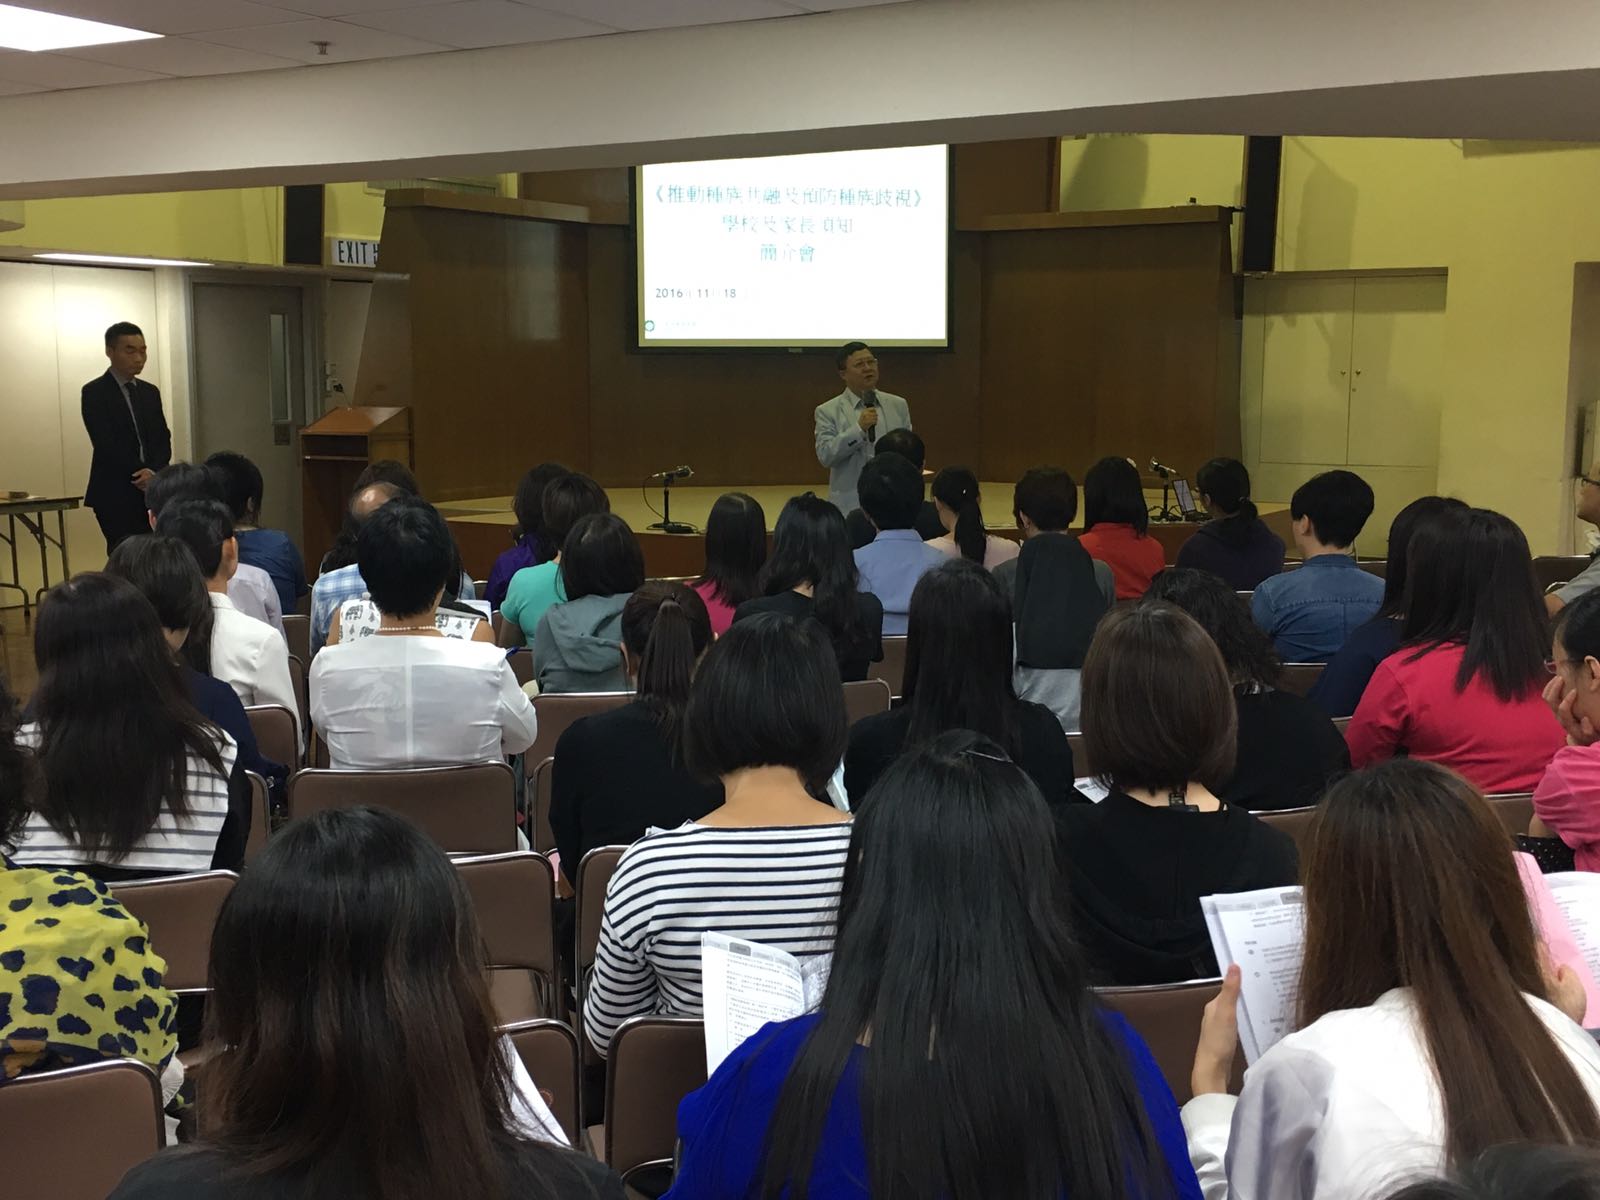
top-left (310, 634), bottom-right (539, 770)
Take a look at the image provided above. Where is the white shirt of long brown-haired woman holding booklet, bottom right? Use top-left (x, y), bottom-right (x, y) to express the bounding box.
top-left (1182, 987), bottom-right (1600, 1200)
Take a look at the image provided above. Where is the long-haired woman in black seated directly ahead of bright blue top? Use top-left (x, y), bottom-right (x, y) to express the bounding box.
top-left (845, 558), bottom-right (1082, 811)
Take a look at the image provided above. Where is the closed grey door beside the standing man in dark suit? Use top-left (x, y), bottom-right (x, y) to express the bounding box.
top-left (194, 283), bottom-right (306, 550)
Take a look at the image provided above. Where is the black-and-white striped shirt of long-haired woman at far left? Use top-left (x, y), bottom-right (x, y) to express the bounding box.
top-left (11, 723), bottom-right (238, 874)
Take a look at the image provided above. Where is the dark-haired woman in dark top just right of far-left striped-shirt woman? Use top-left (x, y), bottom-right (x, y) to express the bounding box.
top-left (106, 533), bottom-right (290, 784)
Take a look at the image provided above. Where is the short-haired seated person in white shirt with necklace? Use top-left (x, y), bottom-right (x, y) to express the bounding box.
top-left (310, 496), bottom-right (538, 770)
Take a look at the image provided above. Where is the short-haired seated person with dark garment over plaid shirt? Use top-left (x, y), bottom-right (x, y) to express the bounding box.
top-left (995, 467), bottom-right (1117, 733)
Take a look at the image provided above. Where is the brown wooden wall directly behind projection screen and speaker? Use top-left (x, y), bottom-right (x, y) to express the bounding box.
top-left (589, 226), bottom-right (981, 486)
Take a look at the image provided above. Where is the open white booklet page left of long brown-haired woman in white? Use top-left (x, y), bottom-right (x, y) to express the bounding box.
top-left (1200, 888), bottom-right (1306, 1064)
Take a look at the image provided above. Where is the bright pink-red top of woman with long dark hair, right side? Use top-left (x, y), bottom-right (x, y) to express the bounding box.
top-left (1344, 645), bottom-right (1566, 803)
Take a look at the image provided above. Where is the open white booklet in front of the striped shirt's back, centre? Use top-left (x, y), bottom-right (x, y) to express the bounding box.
top-left (701, 933), bottom-right (832, 1075)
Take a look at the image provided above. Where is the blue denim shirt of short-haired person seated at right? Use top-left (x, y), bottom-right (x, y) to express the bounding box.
top-left (1250, 554), bottom-right (1384, 662)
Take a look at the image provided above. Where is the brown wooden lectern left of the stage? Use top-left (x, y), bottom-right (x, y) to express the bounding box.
top-left (301, 406), bottom-right (414, 579)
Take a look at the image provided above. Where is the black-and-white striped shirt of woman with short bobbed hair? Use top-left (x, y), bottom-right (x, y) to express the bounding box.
top-left (584, 821), bottom-right (850, 1054)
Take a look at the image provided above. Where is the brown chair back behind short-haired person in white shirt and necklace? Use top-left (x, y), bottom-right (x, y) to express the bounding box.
top-left (286, 763), bottom-right (517, 854)
